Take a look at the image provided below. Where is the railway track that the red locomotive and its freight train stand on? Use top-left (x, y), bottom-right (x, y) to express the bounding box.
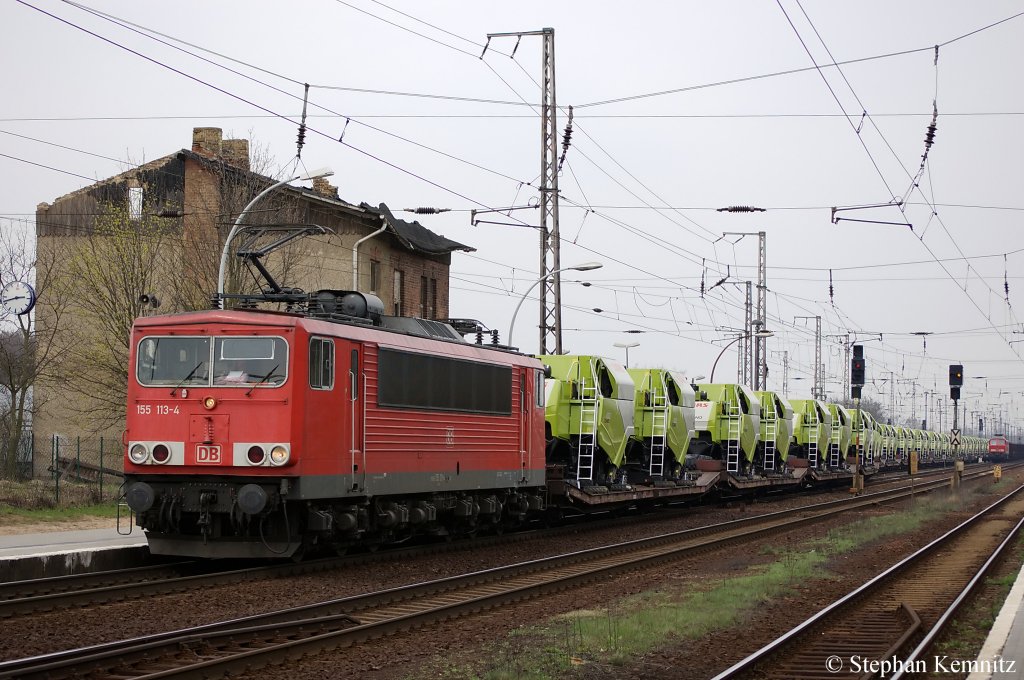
top-left (0, 466), bottom-right (988, 619)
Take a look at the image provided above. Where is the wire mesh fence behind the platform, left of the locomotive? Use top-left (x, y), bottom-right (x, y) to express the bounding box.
top-left (0, 430), bottom-right (124, 507)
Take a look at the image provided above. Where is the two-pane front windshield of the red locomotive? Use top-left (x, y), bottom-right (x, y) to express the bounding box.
top-left (135, 336), bottom-right (288, 387)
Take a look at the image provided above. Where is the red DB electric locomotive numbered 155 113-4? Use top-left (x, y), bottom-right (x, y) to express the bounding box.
top-left (125, 291), bottom-right (545, 557)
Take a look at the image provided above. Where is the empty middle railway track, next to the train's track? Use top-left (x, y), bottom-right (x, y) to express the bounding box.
top-left (0, 464), bottom-right (984, 679)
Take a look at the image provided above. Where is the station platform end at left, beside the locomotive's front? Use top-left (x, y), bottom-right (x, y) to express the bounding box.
top-left (0, 522), bottom-right (150, 582)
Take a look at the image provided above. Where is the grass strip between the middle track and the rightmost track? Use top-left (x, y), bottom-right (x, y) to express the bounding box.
top-left (415, 491), bottom-right (958, 680)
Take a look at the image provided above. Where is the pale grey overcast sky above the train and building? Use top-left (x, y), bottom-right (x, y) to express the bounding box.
top-left (0, 0), bottom-right (1024, 431)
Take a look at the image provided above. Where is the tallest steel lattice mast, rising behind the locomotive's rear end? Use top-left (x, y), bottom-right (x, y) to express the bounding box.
top-left (480, 29), bottom-right (562, 354)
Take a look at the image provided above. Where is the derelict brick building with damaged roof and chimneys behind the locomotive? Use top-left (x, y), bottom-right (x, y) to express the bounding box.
top-left (35, 128), bottom-right (474, 468)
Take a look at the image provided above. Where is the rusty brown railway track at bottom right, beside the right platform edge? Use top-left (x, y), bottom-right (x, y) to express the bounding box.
top-left (715, 486), bottom-right (1024, 680)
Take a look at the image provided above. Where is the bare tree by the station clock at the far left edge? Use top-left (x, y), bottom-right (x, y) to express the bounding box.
top-left (0, 225), bottom-right (75, 479)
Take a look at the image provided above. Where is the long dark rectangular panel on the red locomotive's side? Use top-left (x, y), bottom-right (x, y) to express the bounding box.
top-left (377, 348), bottom-right (512, 416)
